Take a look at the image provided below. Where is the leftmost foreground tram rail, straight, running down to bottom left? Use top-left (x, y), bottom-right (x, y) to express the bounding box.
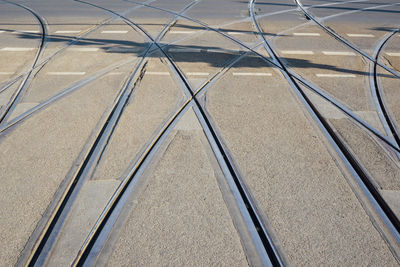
top-left (21, 2), bottom-right (203, 266)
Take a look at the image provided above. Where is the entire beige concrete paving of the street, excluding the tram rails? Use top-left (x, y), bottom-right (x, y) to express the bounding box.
top-left (0, 0), bottom-right (400, 266)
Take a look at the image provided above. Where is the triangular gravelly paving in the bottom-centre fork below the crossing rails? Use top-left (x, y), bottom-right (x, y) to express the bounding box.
top-left (104, 111), bottom-right (247, 266)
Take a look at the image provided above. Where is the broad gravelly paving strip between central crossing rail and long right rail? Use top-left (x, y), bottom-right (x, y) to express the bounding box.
top-left (207, 56), bottom-right (396, 266)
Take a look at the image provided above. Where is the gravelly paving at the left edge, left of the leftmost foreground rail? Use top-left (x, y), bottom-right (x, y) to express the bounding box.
top-left (0, 73), bottom-right (120, 265)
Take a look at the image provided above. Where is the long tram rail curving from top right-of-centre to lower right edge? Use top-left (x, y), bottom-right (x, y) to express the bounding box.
top-left (249, 0), bottom-right (400, 258)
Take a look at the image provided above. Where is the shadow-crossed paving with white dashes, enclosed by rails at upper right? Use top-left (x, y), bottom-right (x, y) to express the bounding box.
top-left (274, 26), bottom-right (370, 111)
